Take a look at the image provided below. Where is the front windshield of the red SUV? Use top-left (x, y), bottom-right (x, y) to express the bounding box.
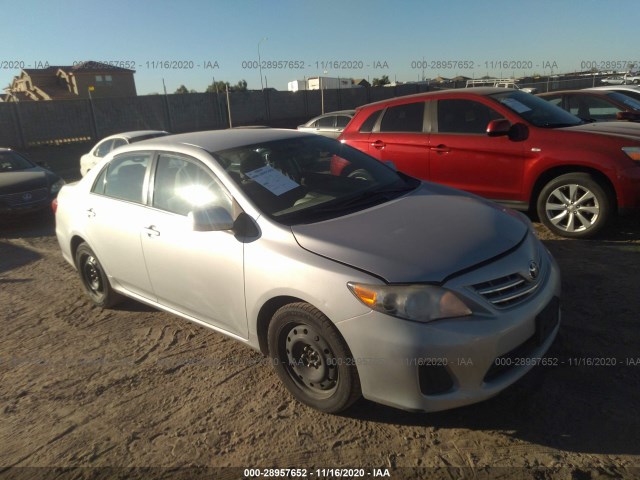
top-left (489, 89), bottom-right (585, 128)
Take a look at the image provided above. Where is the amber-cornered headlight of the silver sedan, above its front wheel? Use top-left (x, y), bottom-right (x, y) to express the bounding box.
top-left (347, 282), bottom-right (471, 322)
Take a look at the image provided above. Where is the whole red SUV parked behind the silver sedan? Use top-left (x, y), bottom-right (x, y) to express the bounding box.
top-left (340, 88), bottom-right (640, 237)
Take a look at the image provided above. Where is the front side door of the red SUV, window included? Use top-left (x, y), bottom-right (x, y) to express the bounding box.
top-left (429, 98), bottom-right (526, 200)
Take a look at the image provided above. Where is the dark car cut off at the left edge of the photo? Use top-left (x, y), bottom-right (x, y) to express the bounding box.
top-left (0, 148), bottom-right (64, 215)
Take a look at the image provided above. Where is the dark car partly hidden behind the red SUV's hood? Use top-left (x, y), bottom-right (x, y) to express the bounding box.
top-left (538, 90), bottom-right (640, 122)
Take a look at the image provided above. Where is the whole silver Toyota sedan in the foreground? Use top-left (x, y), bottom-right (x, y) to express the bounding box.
top-left (56, 129), bottom-right (560, 412)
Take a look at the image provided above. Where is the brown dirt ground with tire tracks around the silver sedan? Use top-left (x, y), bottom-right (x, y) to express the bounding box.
top-left (0, 203), bottom-right (640, 479)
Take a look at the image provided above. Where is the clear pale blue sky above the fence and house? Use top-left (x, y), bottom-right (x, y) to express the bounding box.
top-left (0, 0), bottom-right (640, 95)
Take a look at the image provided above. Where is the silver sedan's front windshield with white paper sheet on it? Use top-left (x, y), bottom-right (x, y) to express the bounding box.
top-left (213, 135), bottom-right (420, 225)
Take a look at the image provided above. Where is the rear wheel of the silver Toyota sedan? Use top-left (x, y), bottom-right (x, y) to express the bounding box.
top-left (75, 243), bottom-right (123, 308)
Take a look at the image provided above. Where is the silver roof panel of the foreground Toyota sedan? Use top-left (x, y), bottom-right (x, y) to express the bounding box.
top-left (136, 128), bottom-right (315, 152)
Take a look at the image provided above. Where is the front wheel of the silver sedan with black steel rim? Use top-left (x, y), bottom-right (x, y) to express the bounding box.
top-left (267, 303), bottom-right (361, 413)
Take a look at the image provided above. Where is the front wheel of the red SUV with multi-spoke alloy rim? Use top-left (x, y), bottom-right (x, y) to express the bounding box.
top-left (536, 172), bottom-right (613, 238)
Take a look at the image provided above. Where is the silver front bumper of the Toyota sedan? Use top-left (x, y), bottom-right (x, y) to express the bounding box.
top-left (338, 238), bottom-right (560, 412)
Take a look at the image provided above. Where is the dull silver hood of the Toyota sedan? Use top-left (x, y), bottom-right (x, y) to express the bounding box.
top-left (291, 183), bottom-right (529, 283)
